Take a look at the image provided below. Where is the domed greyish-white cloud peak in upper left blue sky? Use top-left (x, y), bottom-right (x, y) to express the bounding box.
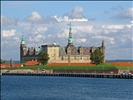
top-left (26, 11), bottom-right (44, 23)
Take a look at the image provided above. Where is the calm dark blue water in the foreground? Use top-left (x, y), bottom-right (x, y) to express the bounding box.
top-left (1, 76), bottom-right (133, 100)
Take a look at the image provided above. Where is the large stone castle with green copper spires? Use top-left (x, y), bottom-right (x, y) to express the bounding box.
top-left (20, 24), bottom-right (105, 63)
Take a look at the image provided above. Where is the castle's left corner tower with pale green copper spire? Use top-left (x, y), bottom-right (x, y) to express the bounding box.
top-left (20, 36), bottom-right (26, 62)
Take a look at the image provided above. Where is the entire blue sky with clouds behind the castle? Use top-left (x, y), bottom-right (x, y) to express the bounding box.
top-left (1, 1), bottom-right (133, 60)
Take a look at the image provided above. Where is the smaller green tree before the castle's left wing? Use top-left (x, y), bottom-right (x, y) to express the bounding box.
top-left (38, 52), bottom-right (49, 65)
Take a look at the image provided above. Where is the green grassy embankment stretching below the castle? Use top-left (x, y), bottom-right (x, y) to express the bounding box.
top-left (1, 64), bottom-right (133, 70)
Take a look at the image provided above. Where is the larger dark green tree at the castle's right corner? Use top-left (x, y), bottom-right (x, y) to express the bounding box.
top-left (90, 49), bottom-right (104, 65)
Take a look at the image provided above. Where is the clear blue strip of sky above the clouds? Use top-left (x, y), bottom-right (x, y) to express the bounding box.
top-left (2, 1), bottom-right (132, 20)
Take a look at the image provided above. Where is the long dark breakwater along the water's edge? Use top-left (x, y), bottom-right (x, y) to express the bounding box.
top-left (2, 73), bottom-right (133, 79)
